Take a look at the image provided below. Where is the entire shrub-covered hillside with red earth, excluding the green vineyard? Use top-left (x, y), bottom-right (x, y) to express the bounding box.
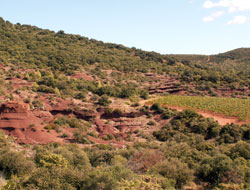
top-left (0, 19), bottom-right (250, 190)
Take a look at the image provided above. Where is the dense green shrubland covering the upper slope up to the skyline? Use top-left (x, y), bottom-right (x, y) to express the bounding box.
top-left (0, 18), bottom-right (250, 93)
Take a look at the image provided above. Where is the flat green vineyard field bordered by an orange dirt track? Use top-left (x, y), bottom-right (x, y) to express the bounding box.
top-left (151, 95), bottom-right (250, 121)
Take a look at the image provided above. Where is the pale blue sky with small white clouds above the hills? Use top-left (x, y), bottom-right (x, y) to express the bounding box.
top-left (0, 0), bottom-right (250, 55)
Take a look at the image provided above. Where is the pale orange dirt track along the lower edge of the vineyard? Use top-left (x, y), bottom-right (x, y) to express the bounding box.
top-left (140, 98), bottom-right (247, 125)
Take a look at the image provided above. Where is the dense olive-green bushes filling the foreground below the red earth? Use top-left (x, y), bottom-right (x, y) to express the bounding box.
top-left (0, 104), bottom-right (250, 190)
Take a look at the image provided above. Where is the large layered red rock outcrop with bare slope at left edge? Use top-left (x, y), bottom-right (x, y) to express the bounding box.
top-left (0, 101), bottom-right (64, 144)
